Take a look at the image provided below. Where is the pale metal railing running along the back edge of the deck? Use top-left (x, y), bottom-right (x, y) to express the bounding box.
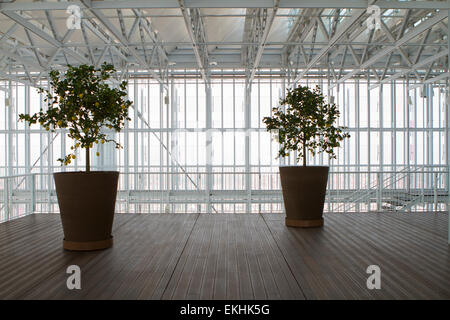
top-left (0, 166), bottom-right (448, 222)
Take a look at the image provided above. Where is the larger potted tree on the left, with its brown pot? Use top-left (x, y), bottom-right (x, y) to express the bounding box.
top-left (19, 63), bottom-right (132, 251)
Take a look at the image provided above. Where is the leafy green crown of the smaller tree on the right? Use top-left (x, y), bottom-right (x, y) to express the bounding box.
top-left (263, 86), bottom-right (350, 166)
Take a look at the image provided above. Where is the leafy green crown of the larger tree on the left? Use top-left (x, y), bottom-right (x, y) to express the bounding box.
top-left (19, 63), bottom-right (132, 171)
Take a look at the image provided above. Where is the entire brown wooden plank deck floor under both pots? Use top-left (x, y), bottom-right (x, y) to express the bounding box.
top-left (0, 213), bottom-right (450, 299)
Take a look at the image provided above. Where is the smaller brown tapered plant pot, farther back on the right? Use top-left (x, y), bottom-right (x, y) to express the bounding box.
top-left (280, 166), bottom-right (328, 227)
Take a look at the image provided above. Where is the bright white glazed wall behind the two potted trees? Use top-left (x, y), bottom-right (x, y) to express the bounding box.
top-left (0, 70), bottom-right (446, 212)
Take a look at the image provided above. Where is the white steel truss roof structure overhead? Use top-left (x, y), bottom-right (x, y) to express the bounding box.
top-left (0, 0), bottom-right (450, 86)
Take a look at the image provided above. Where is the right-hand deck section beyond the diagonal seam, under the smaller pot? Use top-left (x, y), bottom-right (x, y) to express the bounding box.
top-left (266, 214), bottom-right (450, 299)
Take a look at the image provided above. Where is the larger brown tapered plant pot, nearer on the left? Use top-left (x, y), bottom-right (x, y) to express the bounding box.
top-left (53, 171), bottom-right (119, 251)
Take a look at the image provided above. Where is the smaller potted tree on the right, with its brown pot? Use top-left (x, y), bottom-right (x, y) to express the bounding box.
top-left (263, 86), bottom-right (350, 227)
